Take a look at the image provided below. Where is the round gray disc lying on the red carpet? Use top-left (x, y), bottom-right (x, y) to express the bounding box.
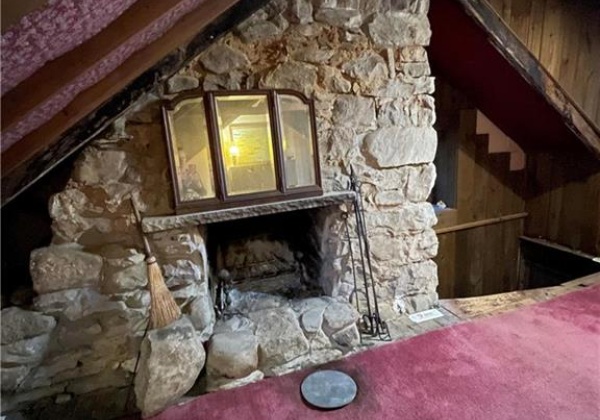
top-left (300, 370), bottom-right (358, 409)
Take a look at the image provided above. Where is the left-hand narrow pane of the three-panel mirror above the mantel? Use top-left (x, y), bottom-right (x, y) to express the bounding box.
top-left (168, 98), bottom-right (215, 201)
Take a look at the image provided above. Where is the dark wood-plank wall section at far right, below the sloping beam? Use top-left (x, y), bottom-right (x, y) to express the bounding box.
top-left (525, 154), bottom-right (600, 256)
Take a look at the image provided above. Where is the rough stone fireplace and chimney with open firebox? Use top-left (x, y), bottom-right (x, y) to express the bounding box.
top-left (2, 0), bottom-right (437, 414)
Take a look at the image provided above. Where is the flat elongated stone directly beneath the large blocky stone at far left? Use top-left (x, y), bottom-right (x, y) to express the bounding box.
top-left (34, 288), bottom-right (127, 321)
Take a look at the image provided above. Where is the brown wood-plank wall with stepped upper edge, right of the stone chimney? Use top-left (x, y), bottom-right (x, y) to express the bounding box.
top-left (433, 78), bottom-right (525, 298)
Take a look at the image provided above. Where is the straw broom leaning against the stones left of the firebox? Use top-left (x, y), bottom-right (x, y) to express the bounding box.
top-left (131, 200), bottom-right (181, 329)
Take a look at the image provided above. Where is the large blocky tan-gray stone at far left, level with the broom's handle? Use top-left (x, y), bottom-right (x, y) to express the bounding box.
top-left (29, 244), bottom-right (102, 294)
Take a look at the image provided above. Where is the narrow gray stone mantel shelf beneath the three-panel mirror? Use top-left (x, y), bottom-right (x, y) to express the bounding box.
top-left (142, 191), bottom-right (356, 233)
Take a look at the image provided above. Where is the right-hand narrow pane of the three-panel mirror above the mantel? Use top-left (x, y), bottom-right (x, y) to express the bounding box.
top-left (278, 95), bottom-right (315, 188)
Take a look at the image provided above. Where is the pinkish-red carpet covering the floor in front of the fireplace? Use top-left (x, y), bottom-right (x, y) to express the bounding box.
top-left (154, 287), bottom-right (600, 420)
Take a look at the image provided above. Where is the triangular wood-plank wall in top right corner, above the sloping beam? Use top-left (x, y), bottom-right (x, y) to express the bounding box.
top-left (487, 0), bottom-right (600, 126)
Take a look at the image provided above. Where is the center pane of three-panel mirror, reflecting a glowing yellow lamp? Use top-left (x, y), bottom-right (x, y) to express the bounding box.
top-left (215, 95), bottom-right (277, 195)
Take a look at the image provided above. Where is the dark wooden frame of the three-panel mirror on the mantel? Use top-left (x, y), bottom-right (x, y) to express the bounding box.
top-left (162, 89), bottom-right (323, 214)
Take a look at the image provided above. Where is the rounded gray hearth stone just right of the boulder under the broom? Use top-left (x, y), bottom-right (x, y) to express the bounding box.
top-left (206, 332), bottom-right (258, 379)
